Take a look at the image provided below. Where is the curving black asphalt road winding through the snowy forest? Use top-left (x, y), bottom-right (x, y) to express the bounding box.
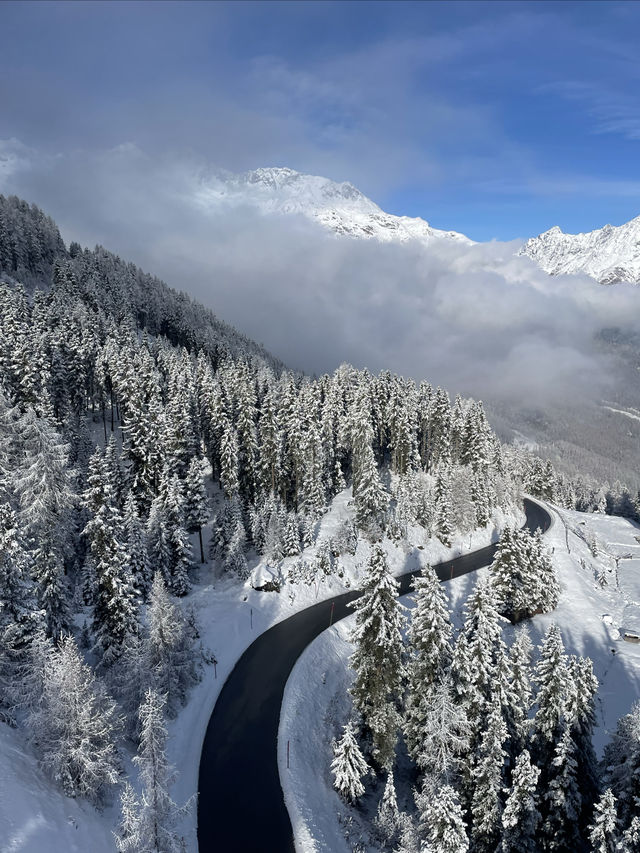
top-left (198, 498), bottom-right (551, 853)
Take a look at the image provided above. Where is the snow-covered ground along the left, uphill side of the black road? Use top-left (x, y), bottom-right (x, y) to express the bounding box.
top-left (0, 482), bottom-right (524, 853)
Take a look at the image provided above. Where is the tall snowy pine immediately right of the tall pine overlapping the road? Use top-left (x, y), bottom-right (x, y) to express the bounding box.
top-left (403, 566), bottom-right (453, 761)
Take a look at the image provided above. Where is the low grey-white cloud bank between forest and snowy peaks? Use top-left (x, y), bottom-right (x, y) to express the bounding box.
top-left (0, 141), bottom-right (640, 406)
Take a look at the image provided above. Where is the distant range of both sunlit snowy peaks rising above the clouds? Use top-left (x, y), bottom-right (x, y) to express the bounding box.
top-left (198, 167), bottom-right (640, 284)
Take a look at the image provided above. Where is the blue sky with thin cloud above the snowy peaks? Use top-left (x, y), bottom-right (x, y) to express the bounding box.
top-left (0, 1), bottom-right (640, 240)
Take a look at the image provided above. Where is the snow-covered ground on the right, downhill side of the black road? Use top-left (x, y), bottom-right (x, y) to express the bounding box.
top-left (278, 502), bottom-right (640, 853)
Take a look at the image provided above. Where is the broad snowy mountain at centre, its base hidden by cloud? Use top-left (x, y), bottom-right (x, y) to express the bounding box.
top-left (192, 168), bottom-right (473, 245)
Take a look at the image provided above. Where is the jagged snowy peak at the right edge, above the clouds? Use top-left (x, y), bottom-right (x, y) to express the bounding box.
top-left (518, 216), bottom-right (640, 284)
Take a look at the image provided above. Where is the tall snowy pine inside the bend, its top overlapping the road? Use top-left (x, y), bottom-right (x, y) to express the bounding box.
top-left (349, 545), bottom-right (404, 767)
